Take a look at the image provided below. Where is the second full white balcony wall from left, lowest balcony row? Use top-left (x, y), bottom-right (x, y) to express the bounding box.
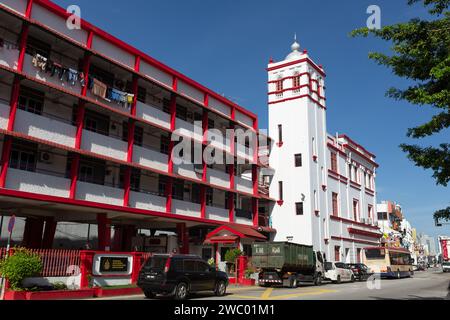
top-left (77, 181), bottom-right (124, 206)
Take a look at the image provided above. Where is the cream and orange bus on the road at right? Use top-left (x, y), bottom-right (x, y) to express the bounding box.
top-left (363, 247), bottom-right (414, 279)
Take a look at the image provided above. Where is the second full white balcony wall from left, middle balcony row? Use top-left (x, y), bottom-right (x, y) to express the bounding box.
top-left (81, 130), bottom-right (128, 161)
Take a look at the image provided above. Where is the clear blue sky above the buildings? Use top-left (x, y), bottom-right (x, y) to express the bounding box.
top-left (55, 0), bottom-right (450, 240)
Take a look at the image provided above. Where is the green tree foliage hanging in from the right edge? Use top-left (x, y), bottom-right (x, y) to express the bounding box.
top-left (351, 0), bottom-right (450, 220)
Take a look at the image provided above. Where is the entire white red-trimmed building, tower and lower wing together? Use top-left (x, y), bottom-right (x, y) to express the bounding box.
top-left (268, 43), bottom-right (379, 262)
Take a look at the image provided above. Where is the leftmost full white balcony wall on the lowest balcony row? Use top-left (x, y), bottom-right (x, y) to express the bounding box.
top-left (6, 168), bottom-right (70, 198)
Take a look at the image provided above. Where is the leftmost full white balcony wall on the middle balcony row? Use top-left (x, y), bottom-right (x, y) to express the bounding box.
top-left (14, 109), bottom-right (76, 148)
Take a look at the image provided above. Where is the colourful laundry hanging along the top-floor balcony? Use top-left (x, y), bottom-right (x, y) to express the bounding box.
top-left (32, 53), bottom-right (134, 108)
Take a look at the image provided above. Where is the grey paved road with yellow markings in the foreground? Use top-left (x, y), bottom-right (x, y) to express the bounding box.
top-left (92, 270), bottom-right (450, 301)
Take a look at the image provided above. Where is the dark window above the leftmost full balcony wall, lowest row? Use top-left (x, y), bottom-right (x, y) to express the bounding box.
top-left (9, 141), bottom-right (38, 172)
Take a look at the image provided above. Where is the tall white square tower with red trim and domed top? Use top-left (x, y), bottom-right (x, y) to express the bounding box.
top-left (267, 39), bottom-right (328, 251)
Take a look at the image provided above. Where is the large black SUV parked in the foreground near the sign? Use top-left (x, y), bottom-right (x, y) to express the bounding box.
top-left (138, 254), bottom-right (228, 300)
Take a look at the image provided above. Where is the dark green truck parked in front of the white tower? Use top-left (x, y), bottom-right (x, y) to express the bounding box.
top-left (252, 242), bottom-right (325, 288)
